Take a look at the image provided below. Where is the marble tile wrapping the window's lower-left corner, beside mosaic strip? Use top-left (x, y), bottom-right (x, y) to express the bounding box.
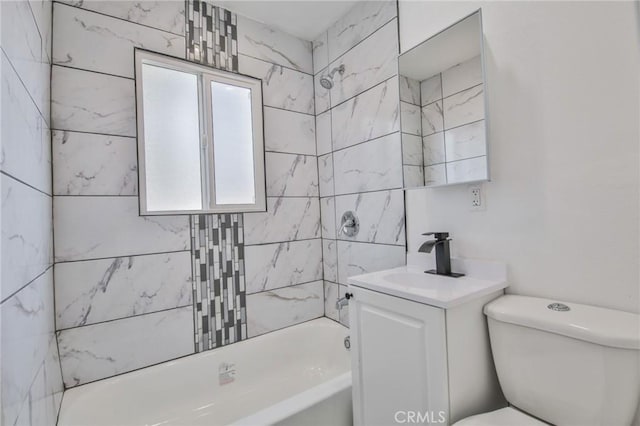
top-left (53, 196), bottom-right (190, 262)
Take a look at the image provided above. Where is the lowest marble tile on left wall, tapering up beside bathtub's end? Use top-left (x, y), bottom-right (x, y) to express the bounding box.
top-left (16, 334), bottom-right (63, 426)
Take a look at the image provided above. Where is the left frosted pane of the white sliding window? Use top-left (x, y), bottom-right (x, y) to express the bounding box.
top-left (142, 64), bottom-right (202, 211)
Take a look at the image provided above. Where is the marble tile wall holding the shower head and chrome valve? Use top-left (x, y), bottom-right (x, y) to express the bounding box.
top-left (313, 1), bottom-right (404, 324)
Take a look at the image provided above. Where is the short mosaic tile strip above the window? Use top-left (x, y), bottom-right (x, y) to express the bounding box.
top-left (187, 0), bottom-right (238, 72)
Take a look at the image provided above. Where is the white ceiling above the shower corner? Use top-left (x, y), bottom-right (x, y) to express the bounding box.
top-left (214, 0), bottom-right (357, 41)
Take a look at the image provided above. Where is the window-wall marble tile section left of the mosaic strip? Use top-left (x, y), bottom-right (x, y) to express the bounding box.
top-left (51, 1), bottom-right (194, 387)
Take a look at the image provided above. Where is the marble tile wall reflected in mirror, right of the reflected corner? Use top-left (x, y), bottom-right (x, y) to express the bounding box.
top-left (420, 56), bottom-right (487, 185)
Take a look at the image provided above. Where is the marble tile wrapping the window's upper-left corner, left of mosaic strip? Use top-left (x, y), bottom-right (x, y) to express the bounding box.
top-left (53, 3), bottom-right (185, 78)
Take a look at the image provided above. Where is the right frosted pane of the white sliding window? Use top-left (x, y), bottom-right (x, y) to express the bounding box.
top-left (211, 82), bottom-right (256, 204)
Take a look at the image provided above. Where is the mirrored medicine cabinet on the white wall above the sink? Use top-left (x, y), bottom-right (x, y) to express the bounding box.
top-left (398, 10), bottom-right (489, 188)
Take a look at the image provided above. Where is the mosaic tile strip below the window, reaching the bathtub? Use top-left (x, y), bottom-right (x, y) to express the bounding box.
top-left (191, 214), bottom-right (247, 352)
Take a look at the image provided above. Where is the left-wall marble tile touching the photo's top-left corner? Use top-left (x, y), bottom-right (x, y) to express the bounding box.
top-left (0, 1), bottom-right (50, 120)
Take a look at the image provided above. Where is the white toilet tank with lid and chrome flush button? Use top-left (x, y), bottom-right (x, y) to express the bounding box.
top-left (484, 295), bottom-right (640, 426)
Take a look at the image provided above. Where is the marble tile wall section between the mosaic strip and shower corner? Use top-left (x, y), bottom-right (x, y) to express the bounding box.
top-left (238, 9), bottom-right (324, 337)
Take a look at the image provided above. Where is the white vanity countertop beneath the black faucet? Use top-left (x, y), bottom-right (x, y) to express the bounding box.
top-left (348, 266), bottom-right (508, 309)
